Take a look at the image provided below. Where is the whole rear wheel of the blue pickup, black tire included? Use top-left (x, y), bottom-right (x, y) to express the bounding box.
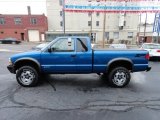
top-left (108, 67), bottom-right (131, 88)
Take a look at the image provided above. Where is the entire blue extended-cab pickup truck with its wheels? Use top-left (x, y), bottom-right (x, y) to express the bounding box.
top-left (7, 36), bottom-right (151, 87)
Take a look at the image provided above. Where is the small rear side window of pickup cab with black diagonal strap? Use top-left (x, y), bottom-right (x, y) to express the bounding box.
top-left (76, 38), bottom-right (88, 52)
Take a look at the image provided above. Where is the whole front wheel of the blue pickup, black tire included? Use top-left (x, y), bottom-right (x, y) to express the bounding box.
top-left (16, 66), bottom-right (39, 87)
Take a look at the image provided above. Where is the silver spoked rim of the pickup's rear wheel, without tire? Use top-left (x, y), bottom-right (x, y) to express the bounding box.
top-left (113, 71), bottom-right (127, 86)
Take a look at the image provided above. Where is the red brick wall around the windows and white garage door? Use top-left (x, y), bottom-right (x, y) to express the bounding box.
top-left (0, 15), bottom-right (48, 41)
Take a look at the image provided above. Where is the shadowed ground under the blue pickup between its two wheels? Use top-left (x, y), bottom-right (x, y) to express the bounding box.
top-left (41, 74), bottom-right (110, 88)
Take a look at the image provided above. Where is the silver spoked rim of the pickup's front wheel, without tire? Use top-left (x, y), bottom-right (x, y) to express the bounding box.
top-left (20, 69), bottom-right (35, 85)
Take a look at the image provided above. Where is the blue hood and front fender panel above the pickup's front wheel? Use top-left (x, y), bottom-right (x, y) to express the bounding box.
top-left (11, 51), bottom-right (41, 63)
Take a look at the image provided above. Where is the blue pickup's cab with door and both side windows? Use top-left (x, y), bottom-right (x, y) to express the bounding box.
top-left (41, 37), bottom-right (93, 73)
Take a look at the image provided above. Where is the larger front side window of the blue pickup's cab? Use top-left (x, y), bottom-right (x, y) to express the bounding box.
top-left (51, 38), bottom-right (74, 52)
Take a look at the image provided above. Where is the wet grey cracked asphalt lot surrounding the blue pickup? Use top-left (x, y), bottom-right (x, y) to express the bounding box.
top-left (0, 43), bottom-right (160, 120)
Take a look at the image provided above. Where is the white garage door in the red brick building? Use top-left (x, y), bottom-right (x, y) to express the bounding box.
top-left (28, 30), bottom-right (40, 42)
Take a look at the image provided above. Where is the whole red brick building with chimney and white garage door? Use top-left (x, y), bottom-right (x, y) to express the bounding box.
top-left (0, 7), bottom-right (48, 41)
